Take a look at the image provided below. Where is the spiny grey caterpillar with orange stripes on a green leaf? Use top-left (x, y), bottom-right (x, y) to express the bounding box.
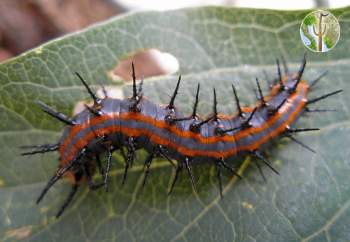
top-left (22, 54), bottom-right (342, 217)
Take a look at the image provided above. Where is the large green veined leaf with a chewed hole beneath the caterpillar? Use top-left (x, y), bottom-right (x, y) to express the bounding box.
top-left (0, 7), bottom-right (350, 242)
